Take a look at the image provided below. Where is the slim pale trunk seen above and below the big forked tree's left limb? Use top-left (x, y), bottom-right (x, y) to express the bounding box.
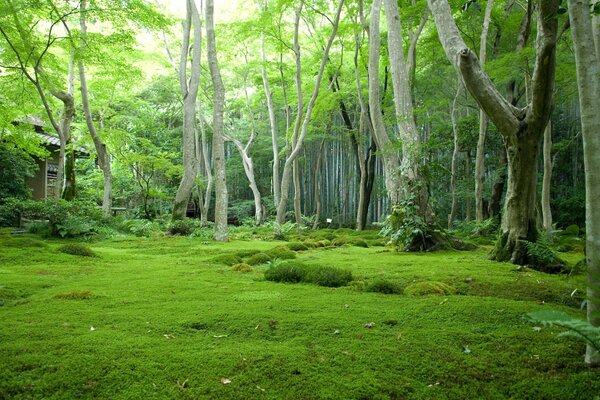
top-left (475, 0), bottom-right (494, 222)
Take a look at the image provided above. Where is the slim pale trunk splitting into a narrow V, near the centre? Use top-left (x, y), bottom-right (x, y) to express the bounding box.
top-left (276, 0), bottom-right (344, 225)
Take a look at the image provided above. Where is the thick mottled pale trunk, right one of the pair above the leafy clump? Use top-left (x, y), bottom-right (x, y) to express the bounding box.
top-left (384, 0), bottom-right (430, 214)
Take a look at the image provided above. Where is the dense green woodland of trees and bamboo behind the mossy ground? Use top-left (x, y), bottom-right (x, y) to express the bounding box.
top-left (0, 0), bottom-right (600, 363)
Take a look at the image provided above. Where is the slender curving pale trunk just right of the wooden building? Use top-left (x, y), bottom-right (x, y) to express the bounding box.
top-left (78, 0), bottom-right (112, 217)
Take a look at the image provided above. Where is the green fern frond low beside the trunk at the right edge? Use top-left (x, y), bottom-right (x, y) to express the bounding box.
top-left (527, 310), bottom-right (600, 351)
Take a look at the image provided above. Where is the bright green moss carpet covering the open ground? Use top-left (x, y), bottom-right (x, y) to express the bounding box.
top-left (0, 230), bottom-right (600, 400)
